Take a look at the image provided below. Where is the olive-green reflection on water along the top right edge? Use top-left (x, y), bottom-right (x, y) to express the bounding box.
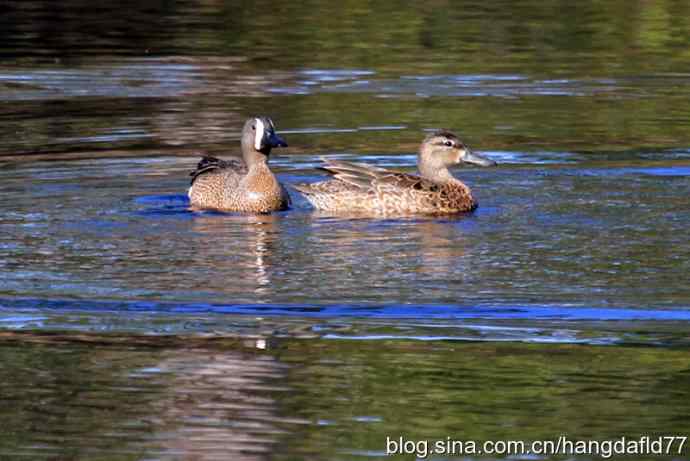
top-left (207, 0), bottom-right (690, 75)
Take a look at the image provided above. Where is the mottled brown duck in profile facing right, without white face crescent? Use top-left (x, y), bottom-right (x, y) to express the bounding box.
top-left (295, 130), bottom-right (496, 215)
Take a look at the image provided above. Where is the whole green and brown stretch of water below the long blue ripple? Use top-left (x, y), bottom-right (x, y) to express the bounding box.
top-left (0, 335), bottom-right (690, 459)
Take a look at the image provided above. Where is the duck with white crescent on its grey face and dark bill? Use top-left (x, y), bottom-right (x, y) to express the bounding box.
top-left (187, 117), bottom-right (290, 213)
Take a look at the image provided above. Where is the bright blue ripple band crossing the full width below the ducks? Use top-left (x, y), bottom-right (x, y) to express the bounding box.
top-left (0, 299), bottom-right (690, 347)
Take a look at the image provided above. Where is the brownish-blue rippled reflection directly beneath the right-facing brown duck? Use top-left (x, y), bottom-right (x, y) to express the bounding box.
top-left (300, 213), bottom-right (472, 303)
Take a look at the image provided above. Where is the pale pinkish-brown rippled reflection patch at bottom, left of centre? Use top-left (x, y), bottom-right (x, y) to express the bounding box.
top-left (148, 339), bottom-right (288, 461)
